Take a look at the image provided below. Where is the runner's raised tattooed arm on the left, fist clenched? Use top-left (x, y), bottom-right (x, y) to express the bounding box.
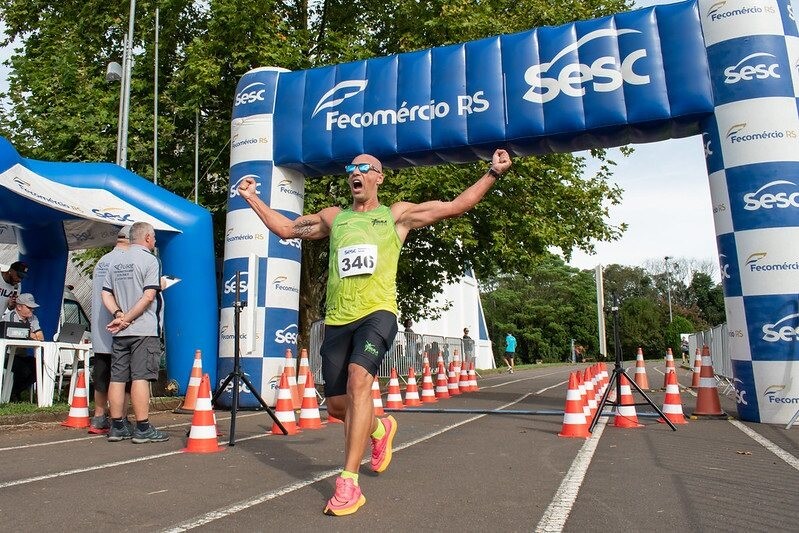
top-left (238, 178), bottom-right (340, 239)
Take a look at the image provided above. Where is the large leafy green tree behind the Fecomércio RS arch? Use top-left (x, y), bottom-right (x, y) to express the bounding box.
top-left (0, 0), bottom-right (631, 338)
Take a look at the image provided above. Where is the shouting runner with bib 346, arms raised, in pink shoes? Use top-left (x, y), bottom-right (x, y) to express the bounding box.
top-left (238, 149), bottom-right (511, 516)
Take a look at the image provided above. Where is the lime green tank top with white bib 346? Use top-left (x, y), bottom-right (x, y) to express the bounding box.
top-left (325, 205), bottom-right (402, 326)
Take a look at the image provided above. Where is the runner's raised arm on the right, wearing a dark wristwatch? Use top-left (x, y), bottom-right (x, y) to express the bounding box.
top-left (391, 145), bottom-right (511, 240)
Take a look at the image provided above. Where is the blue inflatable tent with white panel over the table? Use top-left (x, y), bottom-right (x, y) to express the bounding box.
top-left (0, 137), bottom-right (219, 393)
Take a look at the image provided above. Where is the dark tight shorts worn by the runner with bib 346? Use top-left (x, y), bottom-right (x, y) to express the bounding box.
top-left (320, 311), bottom-right (398, 396)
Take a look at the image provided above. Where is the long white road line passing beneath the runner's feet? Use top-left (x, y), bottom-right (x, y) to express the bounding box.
top-left (162, 393), bottom-right (544, 533)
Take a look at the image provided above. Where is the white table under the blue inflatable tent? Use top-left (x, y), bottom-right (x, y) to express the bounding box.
top-left (0, 339), bottom-right (92, 407)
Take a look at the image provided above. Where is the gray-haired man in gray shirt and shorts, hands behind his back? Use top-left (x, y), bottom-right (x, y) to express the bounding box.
top-left (103, 222), bottom-right (169, 444)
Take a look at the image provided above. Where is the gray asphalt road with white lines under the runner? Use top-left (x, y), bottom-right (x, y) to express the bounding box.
top-left (0, 362), bottom-right (799, 533)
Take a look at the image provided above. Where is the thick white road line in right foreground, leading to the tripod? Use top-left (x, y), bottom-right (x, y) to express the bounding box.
top-left (535, 418), bottom-right (607, 532)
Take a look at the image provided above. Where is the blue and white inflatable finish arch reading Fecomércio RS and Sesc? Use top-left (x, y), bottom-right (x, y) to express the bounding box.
top-left (225, 0), bottom-right (799, 423)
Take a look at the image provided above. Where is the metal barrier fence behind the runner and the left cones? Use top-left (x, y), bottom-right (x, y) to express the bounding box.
top-left (308, 320), bottom-right (474, 383)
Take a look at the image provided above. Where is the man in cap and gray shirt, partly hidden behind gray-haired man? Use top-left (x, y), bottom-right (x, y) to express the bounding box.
top-left (89, 226), bottom-right (133, 435)
